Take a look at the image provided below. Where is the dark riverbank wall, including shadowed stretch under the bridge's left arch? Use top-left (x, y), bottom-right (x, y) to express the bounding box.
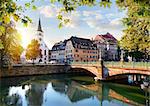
top-left (0, 64), bottom-right (96, 78)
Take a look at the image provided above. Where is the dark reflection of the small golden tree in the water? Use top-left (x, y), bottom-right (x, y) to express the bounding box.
top-left (26, 83), bottom-right (47, 106)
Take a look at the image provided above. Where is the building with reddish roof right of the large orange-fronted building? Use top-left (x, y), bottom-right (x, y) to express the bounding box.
top-left (94, 33), bottom-right (118, 60)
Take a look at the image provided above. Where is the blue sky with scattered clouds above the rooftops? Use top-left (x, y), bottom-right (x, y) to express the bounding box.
top-left (16, 0), bottom-right (126, 49)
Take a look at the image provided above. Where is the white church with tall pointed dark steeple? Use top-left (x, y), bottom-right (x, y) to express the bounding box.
top-left (35, 19), bottom-right (49, 63)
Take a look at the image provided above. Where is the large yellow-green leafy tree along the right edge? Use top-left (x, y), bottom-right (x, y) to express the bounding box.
top-left (117, 0), bottom-right (150, 59)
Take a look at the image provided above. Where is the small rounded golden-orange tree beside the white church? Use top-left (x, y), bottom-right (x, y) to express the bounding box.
top-left (26, 39), bottom-right (41, 64)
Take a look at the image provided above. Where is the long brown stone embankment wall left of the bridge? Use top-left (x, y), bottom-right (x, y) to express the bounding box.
top-left (0, 65), bottom-right (72, 77)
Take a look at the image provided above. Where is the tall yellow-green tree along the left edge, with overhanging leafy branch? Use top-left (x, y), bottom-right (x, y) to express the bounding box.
top-left (0, 0), bottom-right (31, 67)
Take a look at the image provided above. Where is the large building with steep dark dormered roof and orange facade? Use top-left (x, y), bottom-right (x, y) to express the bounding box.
top-left (65, 36), bottom-right (98, 63)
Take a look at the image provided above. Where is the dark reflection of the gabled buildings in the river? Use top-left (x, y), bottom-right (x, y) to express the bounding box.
top-left (52, 81), bottom-right (93, 102)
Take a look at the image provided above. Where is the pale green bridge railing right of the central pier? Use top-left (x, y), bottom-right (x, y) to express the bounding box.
top-left (104, 62), bottom-right (150, 70)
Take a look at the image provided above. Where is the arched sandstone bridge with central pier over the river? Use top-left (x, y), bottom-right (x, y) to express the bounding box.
top-left (71, 62), bottom-right (150, 80)
